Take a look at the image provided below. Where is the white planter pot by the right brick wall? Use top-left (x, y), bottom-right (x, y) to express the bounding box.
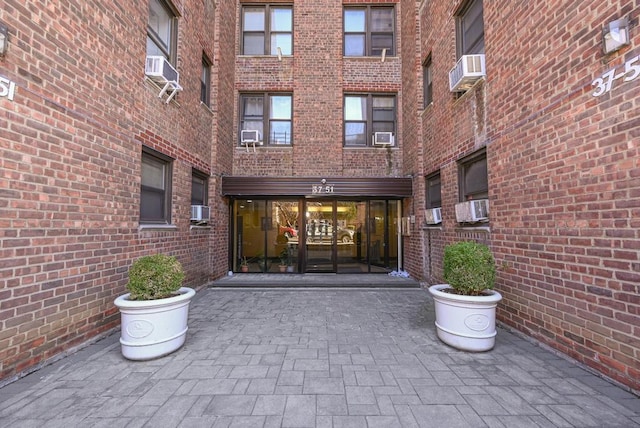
top-left (429, 284), bottom-right (502, 352)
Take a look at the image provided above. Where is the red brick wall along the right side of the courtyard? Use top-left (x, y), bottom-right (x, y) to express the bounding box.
top-left (420, 1), bottom-right (640, 390)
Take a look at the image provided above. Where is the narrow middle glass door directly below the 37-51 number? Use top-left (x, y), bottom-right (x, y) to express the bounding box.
top-left (305, 199), bottom-right (337, 272)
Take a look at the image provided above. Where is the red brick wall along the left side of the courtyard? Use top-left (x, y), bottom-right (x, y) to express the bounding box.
top-left (0, 0), bottom-right (220, 380)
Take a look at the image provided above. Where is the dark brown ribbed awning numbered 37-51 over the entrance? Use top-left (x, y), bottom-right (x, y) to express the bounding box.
top-left (222, 176), bottom-right (412, 198)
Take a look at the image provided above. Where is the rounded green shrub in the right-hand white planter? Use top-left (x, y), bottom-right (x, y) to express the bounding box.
top-left (443, 241), bottom-right (496, 296)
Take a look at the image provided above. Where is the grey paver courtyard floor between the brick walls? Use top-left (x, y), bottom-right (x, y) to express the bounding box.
top-left (0, 288), bottom-right (640, 428)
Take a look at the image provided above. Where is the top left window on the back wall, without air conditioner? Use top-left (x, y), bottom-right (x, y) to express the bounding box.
top-left (241, 5), bottom-right (293, 55)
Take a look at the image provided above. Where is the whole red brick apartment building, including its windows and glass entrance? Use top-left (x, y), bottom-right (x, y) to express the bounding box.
top-left (0, 0), bottom-right (640, 391)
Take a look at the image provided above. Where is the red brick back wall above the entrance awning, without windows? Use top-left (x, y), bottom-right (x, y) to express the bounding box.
top-left (233, 0), bottom-right (402, 177)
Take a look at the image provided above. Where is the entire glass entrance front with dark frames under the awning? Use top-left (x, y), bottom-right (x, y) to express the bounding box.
top-left (231, 198), bottom-right (400, 273)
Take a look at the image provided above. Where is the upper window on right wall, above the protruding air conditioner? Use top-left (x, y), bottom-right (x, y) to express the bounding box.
top-left (456, 0), bottom-right (484, 58)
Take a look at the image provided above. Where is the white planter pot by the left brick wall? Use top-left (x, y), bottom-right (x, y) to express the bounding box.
top-left (114, 287), bottom-right (196, 360)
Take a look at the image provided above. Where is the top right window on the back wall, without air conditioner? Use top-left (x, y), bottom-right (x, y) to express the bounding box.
top-left (343, 6), bottom-right (395, 56)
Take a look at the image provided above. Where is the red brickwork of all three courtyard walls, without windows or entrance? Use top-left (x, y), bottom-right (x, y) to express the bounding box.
top-left (0, 0), bottom-right (640, 390)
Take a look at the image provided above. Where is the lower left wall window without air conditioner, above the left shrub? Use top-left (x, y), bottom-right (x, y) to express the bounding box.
top-left (140, 147), bottom-right (171, 224)
